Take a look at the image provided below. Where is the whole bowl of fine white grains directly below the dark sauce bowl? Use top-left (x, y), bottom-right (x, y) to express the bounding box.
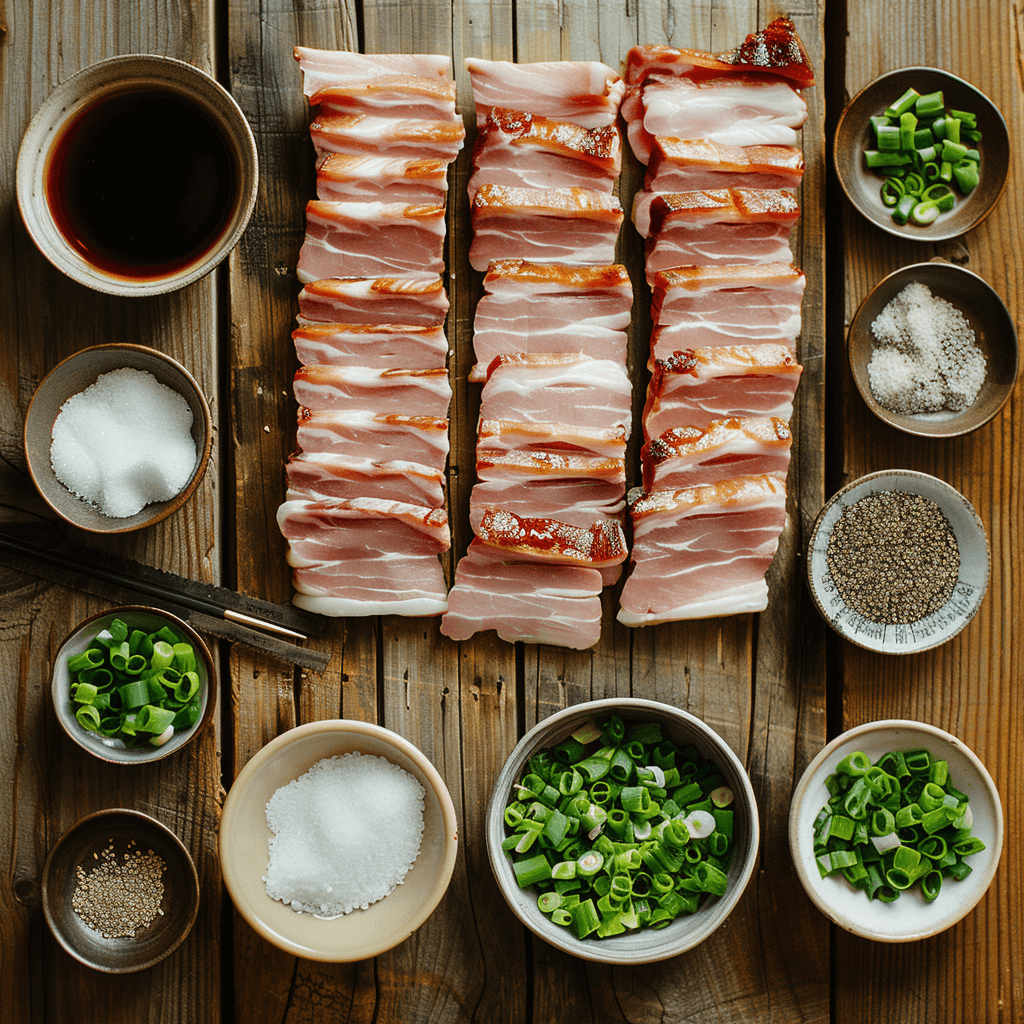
top-left (25, 344), bottom-right (213, 534)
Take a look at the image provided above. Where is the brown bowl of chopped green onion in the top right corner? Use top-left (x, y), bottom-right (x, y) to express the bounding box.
top-left (833, 68), bottom-right (1010, 242)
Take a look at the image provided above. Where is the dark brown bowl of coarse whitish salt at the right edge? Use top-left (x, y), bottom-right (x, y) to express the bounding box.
top-left (847, 259), bottom-right (1018, 437)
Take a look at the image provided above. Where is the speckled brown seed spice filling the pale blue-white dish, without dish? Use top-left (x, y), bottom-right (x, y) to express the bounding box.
top-left (825, 490), bottom-right (959, 625)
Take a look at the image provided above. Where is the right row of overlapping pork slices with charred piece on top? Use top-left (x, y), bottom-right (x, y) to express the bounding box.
top-left (618, 18), bottom-right (813, 626)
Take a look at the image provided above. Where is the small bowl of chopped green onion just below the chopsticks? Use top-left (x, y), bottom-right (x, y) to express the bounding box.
top-left (50, 605), bottom-right (217, 764)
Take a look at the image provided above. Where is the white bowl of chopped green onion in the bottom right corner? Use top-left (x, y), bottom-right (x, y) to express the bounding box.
top-left (790, 719), bottom-right (1002, 942)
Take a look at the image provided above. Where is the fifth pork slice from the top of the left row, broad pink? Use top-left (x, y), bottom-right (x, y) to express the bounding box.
top-left (298, 200), bottom-right (444, 284)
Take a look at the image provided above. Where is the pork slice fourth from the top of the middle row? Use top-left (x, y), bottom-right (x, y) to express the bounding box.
top-left (469, 260), bottom-right (633, 381)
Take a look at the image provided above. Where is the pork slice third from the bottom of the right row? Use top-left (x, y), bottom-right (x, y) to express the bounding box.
top-left (643, 345), bottom-right (803, 440)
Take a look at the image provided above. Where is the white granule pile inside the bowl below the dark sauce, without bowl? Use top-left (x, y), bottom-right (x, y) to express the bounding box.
top-left (50, 367), bottom-right (199, 519)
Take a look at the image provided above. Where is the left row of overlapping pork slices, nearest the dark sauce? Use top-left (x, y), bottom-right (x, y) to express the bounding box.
top-left (278, 47), bottom-right (465, 615)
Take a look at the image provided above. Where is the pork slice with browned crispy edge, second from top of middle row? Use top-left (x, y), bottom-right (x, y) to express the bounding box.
top-left (467, 108), bottom-right (623, 200)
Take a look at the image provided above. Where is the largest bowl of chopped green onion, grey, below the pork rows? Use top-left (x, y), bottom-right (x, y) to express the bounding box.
top-left (486, 698), bottom-right (759, 964)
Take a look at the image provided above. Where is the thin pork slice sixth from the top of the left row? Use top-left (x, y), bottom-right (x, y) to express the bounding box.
top-left (298, 273), bottom-right (449, 327)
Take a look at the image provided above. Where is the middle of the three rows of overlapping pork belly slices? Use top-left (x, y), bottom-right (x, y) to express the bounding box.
top-left (441, 59), bottom-right (633, 648)
